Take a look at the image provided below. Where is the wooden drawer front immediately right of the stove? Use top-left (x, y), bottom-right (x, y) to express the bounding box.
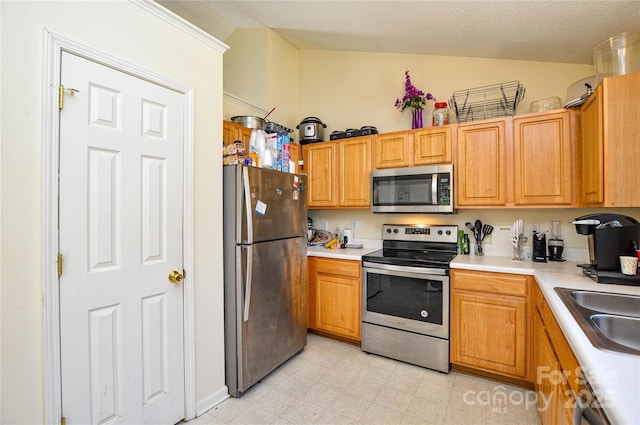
top-left (451, 270), bottom-right (529, 297)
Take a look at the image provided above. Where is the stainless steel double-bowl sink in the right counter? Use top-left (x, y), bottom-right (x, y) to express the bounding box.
top-left (554, 288), bottom-right (640, 356)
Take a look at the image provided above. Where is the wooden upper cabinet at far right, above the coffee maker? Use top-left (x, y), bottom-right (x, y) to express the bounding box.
top-left (581, 72), bottom-right (640, 207)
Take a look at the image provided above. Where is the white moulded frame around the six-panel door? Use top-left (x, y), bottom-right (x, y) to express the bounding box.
top-left (42, 29), bottom-right (196, 424)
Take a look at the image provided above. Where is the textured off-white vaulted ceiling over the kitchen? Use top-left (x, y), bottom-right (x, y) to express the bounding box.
top-left (159, 0), bottom-right (640, 64)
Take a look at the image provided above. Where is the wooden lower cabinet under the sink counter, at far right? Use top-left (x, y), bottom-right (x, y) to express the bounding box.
top-left (531, 285), bottom-right (579, 425)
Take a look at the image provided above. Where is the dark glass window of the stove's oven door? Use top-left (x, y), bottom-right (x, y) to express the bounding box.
top-left (366, 273), bottom-right (448, 325)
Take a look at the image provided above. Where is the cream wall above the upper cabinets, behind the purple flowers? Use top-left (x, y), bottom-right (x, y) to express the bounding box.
top-left (298, 50), bottom-right (593, 134)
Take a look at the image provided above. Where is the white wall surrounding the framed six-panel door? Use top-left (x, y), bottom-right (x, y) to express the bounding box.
top-left (0, 1), bottom-right (226, 424)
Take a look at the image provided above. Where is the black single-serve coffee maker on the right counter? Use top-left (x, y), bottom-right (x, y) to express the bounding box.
top-left (572, 214), bottom-right (640, 286)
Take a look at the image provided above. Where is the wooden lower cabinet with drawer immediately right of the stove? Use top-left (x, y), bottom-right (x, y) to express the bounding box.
top-left (451, 270), bottom-right (532, 381)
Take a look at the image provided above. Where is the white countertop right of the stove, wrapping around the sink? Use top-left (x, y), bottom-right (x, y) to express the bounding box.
top-left (451, 255), bottom-right (640, 424)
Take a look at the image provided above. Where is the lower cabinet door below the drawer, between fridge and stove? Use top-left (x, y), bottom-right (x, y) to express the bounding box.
top-left (316, 274), bottom-right (361, 340)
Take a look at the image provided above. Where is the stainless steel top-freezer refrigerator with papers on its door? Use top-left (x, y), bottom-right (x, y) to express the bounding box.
top-left (223, 165), bottom-right (307, 397)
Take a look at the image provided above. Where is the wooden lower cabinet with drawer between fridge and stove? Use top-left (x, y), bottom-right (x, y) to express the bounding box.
top-left (308, 257), bottom-right (362, 342)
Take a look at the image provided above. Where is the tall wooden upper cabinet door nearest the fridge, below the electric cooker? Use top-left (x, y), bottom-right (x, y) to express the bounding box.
top-left (302, 142), bottom-right (337, 207)
